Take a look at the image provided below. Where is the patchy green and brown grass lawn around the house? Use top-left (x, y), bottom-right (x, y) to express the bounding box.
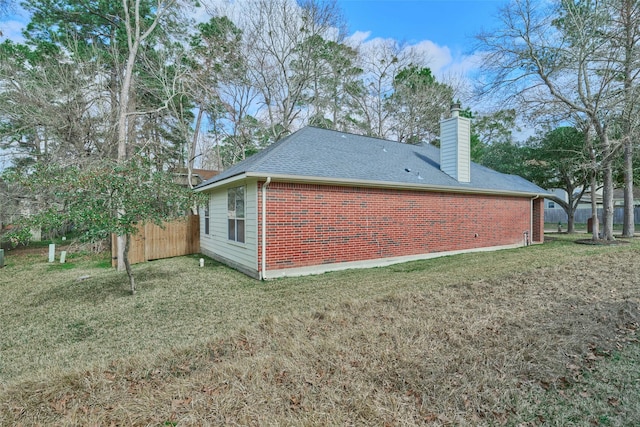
top-left (0, 235), bottom-right (640, 426)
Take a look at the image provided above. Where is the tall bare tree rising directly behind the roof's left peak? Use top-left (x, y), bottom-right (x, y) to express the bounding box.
top-left (239, 0), bottom-right (340, 141)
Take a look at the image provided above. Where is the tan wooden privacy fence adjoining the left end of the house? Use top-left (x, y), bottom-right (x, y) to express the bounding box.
top-left (111, 215), bottom-right (200, 267)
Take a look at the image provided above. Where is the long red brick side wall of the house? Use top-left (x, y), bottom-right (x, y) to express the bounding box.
top-left (258, 182), bottom-right (531, 270)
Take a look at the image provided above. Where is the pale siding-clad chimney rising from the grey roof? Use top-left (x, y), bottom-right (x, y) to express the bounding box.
top-left (440, 104), bottom-right (471, 182)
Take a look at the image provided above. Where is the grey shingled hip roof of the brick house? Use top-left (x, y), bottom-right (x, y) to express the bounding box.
top-left (196, 126), bottom-right (548, 195)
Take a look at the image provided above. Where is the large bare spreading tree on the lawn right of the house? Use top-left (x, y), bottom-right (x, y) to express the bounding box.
top-left (478, 0), bottom-right (622, 240)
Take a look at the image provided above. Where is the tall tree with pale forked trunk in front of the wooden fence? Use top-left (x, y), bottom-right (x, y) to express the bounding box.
top-left (10, 0), bottom-right (198, 288)
